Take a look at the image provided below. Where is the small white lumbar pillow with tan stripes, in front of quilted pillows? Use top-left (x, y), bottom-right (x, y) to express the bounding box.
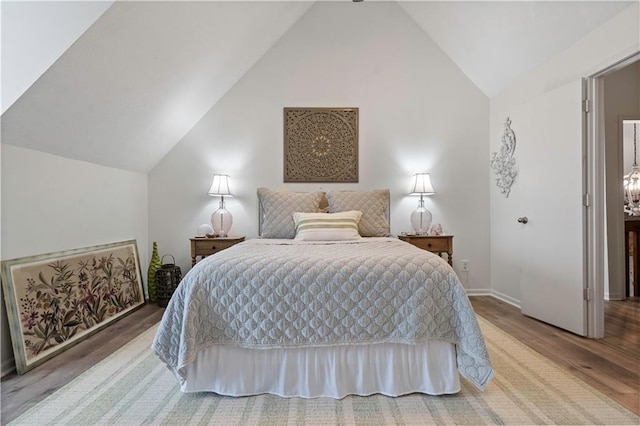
top-left (293, 210), bottom-right (362, 241)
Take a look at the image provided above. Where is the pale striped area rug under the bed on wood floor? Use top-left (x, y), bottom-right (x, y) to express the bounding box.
top-left (11, 318), bottom-right (640, 425)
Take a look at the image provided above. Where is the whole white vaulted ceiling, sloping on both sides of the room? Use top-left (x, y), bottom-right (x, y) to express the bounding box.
top-left (1, 0), bottom-right (634, 173)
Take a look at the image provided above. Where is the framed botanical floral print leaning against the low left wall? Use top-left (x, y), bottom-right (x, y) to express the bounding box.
top-left (2, 240), bottom-right (146, 374)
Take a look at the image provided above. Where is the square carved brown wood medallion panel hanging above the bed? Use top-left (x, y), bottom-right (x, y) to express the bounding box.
top-left (284, 108), bottom-right (358, 182)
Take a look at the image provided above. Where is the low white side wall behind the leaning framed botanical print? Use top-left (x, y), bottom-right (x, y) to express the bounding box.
top-left (0, 144), bottom-right (149, 374)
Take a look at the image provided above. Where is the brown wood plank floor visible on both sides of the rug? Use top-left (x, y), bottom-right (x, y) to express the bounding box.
top-left (0, 297), bottom-right (640, 425)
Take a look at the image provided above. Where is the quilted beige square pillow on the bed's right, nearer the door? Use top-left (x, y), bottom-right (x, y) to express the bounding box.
top-left (326, 189), bottom-right (391, 237)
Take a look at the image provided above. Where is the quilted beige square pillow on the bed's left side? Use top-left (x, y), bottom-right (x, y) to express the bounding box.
top-left (258, 188), bottom-right (323, 239)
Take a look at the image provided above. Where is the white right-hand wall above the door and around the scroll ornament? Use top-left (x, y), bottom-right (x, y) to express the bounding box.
top-left (489, 3), bottom-right (640, 304)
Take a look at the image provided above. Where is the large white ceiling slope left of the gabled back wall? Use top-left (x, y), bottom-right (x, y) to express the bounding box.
top-left (2, 2), bottom-right (313, 173)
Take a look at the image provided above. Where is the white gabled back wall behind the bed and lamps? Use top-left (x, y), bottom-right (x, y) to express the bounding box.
top-left (149, 2), bottom-right (489, 290)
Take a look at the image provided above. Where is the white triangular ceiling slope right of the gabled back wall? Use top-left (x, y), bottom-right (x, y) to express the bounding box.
top-left (399, 0), bottom-right (637, 97)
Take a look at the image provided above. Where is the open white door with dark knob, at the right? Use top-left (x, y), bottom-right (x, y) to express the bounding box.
top-left (512, 80), bottom-right (587, 336)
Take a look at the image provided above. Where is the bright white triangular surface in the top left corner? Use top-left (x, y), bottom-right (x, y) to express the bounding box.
top-left (0, 1), bottom-right (113, 114)
